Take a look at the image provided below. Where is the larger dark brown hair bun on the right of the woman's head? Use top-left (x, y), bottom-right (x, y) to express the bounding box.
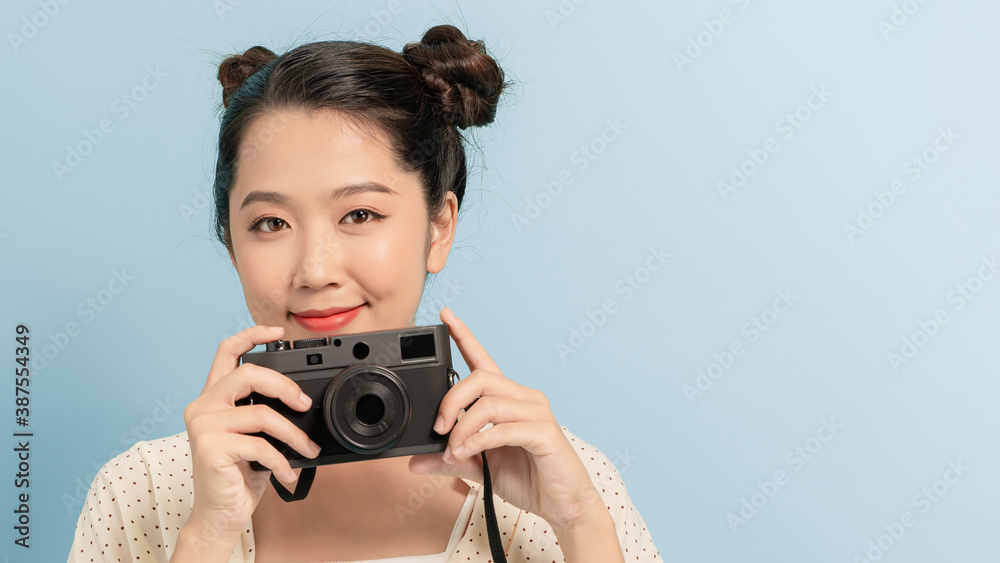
top-left (403, 25), bottom-right (504, 129)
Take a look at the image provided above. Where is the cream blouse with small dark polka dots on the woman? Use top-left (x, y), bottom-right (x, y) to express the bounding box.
top-left (69, 427), bottom-right (660, 563)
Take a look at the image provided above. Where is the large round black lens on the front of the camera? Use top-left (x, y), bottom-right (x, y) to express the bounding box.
top-left (323, 364), bottom-right (410, 454)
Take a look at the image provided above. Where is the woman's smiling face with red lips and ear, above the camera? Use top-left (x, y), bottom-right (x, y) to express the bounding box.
top-left (229, 111), bottom-right (457, 340)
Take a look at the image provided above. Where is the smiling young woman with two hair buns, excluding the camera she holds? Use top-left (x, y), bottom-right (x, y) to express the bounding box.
top-left (69, 26), bottom-right (659, 563)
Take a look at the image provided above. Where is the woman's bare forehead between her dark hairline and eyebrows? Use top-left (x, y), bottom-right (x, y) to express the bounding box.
top-left (230, 110), bottom-right (420, 203)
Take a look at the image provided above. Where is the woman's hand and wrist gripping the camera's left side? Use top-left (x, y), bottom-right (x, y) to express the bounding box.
top-left (172, 326), bottom-right (319, 561)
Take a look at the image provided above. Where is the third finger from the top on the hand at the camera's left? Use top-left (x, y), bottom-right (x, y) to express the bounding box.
top-left (193, 405), bottom-right (320, 458)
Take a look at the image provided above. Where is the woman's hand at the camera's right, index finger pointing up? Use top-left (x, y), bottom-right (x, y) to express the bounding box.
top-left (410, 307), bottom-right (610, 534)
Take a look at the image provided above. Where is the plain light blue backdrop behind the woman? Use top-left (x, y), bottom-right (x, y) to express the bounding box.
top-left (0, 0), bottom-right (1000, 562)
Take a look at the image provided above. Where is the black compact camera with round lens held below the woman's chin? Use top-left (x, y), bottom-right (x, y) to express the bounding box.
top-left (239, 324), bottom-right (457, 470)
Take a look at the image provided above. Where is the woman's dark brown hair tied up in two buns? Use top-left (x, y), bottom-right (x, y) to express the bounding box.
top-left (214, 25), bottom-right (504, 250)
